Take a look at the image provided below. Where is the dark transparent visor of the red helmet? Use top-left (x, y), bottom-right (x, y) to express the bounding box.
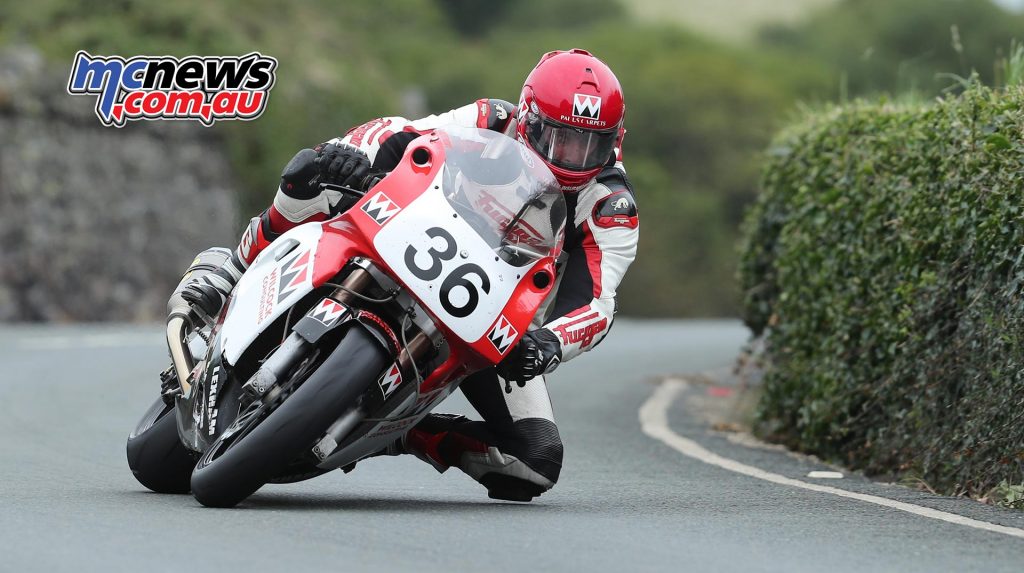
top-left (525, 116), bottom-right (618, 171)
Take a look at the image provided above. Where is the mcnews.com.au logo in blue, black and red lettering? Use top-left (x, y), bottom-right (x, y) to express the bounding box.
top-left (68, 50), bottom-right (278, 127)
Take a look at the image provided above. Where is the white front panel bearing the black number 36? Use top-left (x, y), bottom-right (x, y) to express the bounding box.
top-left (374, 173), bottom-right (528, 343)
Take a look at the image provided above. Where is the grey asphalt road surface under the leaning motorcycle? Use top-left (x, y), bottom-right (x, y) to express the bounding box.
top-left (0, 319), bottom-right (1024, 572)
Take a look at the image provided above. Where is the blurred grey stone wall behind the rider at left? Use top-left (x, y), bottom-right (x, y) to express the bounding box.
top-left (0, 48), bottom-right (241, 321)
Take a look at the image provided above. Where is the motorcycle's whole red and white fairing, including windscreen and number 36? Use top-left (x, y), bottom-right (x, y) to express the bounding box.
top-left (221, 128), bottom-right (565, 437)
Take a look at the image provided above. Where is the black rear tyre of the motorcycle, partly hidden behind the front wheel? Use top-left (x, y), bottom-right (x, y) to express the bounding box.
top-left (127, 398), bottom-right (196, 493)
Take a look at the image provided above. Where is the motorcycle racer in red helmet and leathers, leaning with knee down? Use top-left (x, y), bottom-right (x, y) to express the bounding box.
top-left (182, 49), bottom-right (639, 501)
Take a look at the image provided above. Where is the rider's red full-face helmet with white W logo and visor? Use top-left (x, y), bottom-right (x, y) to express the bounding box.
top-left (516, 49), bottom-right (626, 190)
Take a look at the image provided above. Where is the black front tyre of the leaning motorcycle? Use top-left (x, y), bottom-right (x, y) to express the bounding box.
top-left (191, 326), bottom-right (388, 508)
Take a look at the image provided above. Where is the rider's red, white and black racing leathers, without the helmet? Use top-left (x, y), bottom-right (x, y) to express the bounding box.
top-left (203, 99), bottom-right (639, 500)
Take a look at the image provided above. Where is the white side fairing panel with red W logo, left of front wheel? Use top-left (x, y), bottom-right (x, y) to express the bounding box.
top-left (221, 223), bottom-right (324, 364)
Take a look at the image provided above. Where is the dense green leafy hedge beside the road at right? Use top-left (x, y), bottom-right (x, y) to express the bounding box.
top-left (739, 83), bottom-right (1024, 493)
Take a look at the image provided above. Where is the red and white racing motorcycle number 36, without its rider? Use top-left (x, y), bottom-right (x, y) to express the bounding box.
top-left (127, 127), bottom-right (566, 508)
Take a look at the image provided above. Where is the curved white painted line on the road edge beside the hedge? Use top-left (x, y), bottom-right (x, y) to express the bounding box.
top-left (640, 380), bottom-right (1024, 539)
